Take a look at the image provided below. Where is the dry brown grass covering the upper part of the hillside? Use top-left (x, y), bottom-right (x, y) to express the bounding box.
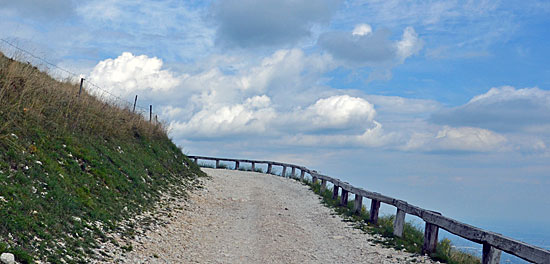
top-left (0, 53), bottom-right (166, 141)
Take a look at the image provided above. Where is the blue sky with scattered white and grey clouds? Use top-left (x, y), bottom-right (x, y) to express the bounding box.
top-left (0, 0), bottom-right (550, 252)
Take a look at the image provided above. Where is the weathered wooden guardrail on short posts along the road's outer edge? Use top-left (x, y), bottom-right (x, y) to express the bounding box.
top-left (188, 156), bottom-right (550, 264)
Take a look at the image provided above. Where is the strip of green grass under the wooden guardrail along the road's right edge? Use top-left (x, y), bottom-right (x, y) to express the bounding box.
top-left (304, 180), bottom-right (481, 264)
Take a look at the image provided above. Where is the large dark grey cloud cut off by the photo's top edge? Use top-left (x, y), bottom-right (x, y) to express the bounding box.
top-left (211, 0), bottom-right (342, 48)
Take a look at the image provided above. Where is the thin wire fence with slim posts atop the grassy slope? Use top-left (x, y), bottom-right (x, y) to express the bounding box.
top-left (0, 38), bottom-right (157, 121)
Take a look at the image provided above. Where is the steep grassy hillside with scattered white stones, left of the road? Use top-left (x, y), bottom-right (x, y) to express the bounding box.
top-left (0, 53), bottom-right (203, 263)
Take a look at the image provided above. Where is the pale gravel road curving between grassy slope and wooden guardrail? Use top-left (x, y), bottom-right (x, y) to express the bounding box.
top-left (108, 169), bottom-right (438, 263)
